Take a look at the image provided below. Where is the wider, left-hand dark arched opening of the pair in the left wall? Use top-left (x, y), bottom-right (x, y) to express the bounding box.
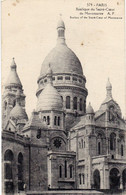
top-left (4, 150), bottom-right (14, 194)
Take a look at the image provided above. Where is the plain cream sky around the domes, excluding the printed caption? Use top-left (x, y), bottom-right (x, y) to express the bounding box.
top-left (2, 0), bottom-right (126, 117)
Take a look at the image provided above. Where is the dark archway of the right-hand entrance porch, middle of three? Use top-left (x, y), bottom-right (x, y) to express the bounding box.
top-left (109, 168), bottom-right (120, 189)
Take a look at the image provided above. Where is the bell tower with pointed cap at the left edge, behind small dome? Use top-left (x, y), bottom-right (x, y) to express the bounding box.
top-left (2, 58), bottom-right (25, 128)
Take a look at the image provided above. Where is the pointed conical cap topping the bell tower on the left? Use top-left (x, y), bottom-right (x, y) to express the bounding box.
top-left (5, 58), bottom-right (22, 87)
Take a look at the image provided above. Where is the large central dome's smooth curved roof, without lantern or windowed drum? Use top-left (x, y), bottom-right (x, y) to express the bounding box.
top-left (40, 44), bottom-right (83, 76)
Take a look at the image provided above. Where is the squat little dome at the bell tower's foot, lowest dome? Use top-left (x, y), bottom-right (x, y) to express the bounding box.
top-left (10, 103), bottom-right (28, 120)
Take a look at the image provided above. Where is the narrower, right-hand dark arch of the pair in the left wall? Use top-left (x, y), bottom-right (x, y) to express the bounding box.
top-left (18, 152), bottom-right (23, 190)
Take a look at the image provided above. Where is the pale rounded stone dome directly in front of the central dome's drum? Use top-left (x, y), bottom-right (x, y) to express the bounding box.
top-left (37, 83), bottom-right (63, 111)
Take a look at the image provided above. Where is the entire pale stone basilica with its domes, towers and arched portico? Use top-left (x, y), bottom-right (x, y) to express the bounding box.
top-left (2, 19), bottom-right (126, 194)
